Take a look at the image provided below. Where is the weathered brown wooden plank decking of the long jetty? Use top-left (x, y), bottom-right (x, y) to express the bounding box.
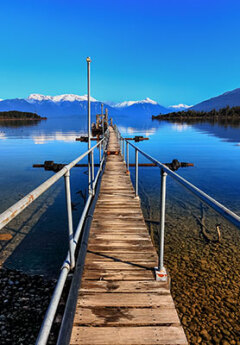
top-left (70, 127), bottom-right (187, 345)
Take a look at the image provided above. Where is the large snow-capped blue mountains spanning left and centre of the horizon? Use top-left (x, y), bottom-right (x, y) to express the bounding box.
top-left (0, 93), bottom-right (169, 118)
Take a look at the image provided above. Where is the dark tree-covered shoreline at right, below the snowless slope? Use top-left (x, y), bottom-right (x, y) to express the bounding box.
top-left (152, 106), bottom-right (240, 120)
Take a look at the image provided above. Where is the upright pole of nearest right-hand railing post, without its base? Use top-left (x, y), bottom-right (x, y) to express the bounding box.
top-left (158, 169), bottom-right (167, 271)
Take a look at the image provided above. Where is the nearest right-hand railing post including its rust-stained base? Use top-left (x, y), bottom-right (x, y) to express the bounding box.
top-left (155, 169), bottom-right (167, 281)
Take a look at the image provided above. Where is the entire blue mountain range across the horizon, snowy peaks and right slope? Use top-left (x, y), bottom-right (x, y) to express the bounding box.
top-left (0, 88), bottom-right (240, 119)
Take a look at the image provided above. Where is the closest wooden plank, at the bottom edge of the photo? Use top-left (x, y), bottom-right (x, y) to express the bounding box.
top-left (70, 326), bottom-right (187, 345)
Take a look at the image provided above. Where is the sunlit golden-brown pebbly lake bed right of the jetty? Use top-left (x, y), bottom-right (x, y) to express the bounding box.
top-left (144, 191), bottom-right (240, 345)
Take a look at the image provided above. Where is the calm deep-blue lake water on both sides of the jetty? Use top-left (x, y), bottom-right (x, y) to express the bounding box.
top-left (0, 118), bottom-right (240, 274)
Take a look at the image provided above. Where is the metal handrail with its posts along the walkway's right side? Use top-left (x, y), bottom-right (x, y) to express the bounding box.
top-left (114, 126), bottom-right (240, 275)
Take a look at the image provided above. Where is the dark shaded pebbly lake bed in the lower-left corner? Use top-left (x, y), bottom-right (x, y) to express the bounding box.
top-left (0, 268), bottom-right (56, 345)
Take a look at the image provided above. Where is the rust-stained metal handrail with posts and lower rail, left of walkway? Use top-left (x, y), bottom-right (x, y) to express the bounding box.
top-left (0, 130), bottom-right (109, 345)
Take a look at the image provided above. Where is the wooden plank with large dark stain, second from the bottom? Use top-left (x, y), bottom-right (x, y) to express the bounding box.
top-left (74, 307), bottom-right (179, 327)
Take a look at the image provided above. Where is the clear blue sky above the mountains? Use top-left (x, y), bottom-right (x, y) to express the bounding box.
top-left (0, 0), bottom-right (240, 106)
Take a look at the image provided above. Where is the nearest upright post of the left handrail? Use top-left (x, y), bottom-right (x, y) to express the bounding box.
top-left (64, 171), bottom-right (75, 268)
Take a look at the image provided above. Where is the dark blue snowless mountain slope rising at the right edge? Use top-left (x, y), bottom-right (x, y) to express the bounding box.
top-left (191, 88), bottom-right (240, 111)
